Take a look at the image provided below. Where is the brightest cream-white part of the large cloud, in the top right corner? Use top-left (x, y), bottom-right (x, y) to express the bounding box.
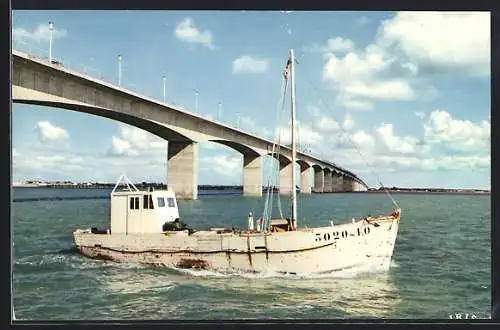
top-left (378, 12), bottom-right (491, 75)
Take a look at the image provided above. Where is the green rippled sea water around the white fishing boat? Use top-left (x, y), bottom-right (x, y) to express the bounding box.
top-left (12, 188), bottom-right (491, 320)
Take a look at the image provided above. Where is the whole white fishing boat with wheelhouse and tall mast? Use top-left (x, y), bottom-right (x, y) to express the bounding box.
top-left (73, 50), bottom-right (401, 274)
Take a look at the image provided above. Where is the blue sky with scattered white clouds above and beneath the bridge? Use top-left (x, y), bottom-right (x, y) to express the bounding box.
top-left (12, 11), bottom-right (491, 189)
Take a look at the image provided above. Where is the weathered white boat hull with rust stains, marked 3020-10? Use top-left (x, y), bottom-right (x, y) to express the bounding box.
top-left (73, 217), bottom-right (399, 274)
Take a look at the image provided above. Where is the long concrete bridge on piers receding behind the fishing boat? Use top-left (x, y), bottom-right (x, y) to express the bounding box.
top-left (12, 50), bottom-right (368, 199)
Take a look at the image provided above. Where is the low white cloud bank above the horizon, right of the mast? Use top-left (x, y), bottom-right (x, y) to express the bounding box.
top-left (302, 106), bottom-right (490, 176)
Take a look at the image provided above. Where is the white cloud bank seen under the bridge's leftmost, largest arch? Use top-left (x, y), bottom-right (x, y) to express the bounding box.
top-left (14, 125), bottom-right (168, 182)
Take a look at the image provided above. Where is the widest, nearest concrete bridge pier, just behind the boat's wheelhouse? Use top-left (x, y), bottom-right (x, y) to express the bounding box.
top-left (167, 141), bottom-right (198, 199)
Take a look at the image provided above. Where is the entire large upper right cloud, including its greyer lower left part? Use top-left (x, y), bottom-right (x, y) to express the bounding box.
top-left (316, 12), bottom-right (490, 110)
